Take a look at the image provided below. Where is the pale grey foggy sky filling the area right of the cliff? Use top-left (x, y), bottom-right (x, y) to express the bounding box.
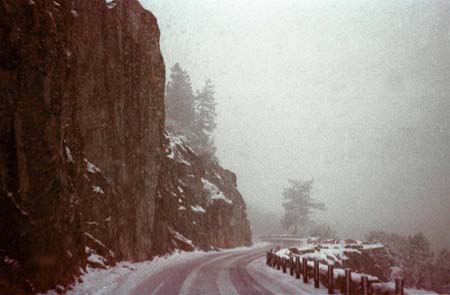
top-left (141, 0), bottom-right (450, 247)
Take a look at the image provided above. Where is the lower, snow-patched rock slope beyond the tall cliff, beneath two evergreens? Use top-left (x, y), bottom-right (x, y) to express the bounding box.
top-left (155, 134), bottom-right (251, 251)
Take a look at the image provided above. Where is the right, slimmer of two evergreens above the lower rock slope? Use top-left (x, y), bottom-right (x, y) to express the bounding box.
top-left (191, 79), bottom-right (217, 158)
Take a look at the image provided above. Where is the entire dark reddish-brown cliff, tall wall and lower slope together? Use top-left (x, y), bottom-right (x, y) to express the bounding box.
top-left (0, 0), bottom-right (251, 294)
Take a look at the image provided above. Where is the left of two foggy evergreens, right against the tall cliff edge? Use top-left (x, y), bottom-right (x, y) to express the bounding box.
top-left (165, 63), bottom-right (195, 136)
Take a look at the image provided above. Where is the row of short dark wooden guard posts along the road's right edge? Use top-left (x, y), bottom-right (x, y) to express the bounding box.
top-left (266, 249), bottom-right (405, 295)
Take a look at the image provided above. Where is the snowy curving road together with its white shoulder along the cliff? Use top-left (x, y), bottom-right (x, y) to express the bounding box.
top-left (53, 244), bottom-right (326, 295)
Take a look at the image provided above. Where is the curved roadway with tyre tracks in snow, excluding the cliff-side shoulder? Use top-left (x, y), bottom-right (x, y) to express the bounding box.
top-left (131, 248), bottom-right (326, 295)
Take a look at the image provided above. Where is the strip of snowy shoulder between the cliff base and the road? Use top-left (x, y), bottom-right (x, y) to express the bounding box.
top-left (41, 243), bottom-right (267, 295)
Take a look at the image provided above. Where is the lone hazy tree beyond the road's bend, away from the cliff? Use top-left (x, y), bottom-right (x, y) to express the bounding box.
top-left (281, 180), bottom-right (325, 235)
